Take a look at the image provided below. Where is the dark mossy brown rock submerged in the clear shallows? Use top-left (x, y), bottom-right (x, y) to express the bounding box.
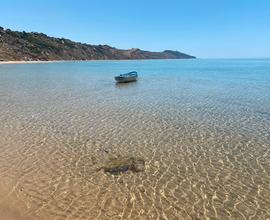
top-left (101, 157), bottom-right (145, 175)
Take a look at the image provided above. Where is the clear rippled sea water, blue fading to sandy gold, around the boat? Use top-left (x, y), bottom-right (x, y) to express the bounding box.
top-left (0, 59), bottom-right (270, 219)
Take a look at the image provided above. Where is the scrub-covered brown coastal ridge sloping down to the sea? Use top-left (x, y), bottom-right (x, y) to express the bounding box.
top-left (0, 27), bottom-right (196, 61)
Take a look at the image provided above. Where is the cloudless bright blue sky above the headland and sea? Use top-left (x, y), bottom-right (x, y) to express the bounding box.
top-left (0, 0), bottom-right (270, 58)
